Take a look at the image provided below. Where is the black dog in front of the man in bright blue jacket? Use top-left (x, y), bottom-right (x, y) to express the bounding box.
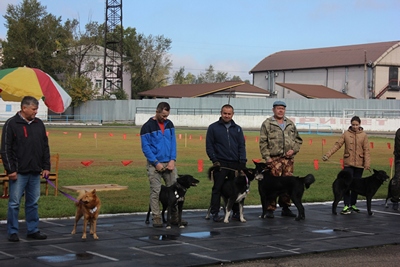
top-left (146, 174), bottom-right (200, 229)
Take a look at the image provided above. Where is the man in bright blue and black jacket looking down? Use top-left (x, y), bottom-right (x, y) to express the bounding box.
top-left (140, 102), bottom-right (180, 227)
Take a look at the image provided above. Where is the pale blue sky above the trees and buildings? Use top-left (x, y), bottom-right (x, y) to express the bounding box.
top-left (0, 0), bottom-right (400, 81)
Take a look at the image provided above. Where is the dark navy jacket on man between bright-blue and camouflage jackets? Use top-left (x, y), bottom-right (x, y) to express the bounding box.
top-left (206, 118), bottom-right (247, 163)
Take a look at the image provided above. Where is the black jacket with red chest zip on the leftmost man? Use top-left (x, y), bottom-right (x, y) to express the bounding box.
top-left (1, 113), bottom-right (50, 174)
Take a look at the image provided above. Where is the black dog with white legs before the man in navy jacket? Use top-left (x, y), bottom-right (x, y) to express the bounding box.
top-left (206, 167), bottom-right (254, 223)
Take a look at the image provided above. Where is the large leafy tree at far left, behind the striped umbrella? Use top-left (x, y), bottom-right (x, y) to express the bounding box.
top-left (3, 0), bottom-right (70, 77)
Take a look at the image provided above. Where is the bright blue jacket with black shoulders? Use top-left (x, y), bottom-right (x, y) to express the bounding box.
top-left (140, 117), bottom-right (176, 166)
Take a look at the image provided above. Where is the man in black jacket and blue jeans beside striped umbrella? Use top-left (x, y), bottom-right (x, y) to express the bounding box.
top-left (1, 96), bottom-right (50, 242)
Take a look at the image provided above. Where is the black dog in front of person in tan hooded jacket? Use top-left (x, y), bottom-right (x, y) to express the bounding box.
top-left (332, 169), bottom-right (389, 215)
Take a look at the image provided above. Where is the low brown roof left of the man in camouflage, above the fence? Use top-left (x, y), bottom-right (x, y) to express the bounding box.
top-left (139, 82), bottom-right (268, 98)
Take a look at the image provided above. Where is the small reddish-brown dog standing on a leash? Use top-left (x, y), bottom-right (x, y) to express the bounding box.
top-left (71, 189), bottom-right (101, 239)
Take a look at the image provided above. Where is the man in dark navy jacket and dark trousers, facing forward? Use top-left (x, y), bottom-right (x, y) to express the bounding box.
top-left (206, 104), bottom-right (247, 222)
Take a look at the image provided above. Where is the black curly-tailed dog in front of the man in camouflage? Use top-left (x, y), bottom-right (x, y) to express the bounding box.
top-left (254, 162), bottom-right (315, 221)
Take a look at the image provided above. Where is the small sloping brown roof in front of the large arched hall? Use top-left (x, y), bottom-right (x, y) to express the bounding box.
top-left (276, 83), bottom-right (354, 99)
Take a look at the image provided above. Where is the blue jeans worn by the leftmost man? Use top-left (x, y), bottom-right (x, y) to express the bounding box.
top-left (7, 173), bottom-right (40, 236)
